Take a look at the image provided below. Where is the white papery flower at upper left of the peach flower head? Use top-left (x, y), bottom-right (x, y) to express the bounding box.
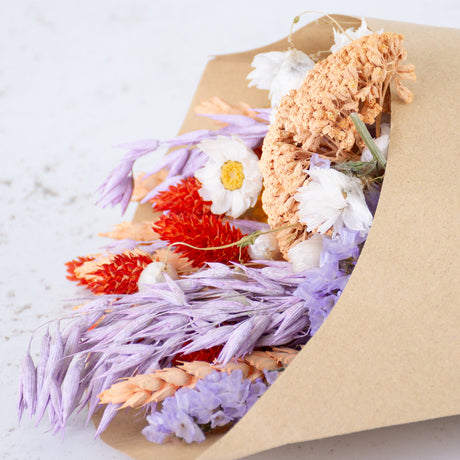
top-left (248, 48), bottom-right (315, 108)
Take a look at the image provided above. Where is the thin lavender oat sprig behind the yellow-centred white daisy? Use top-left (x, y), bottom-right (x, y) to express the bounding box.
top-left (97, 109), bottom-right (268, 212)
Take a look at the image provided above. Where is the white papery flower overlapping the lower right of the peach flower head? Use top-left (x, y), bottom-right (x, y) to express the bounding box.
top-left (295, 168), bottom-right (372, 235)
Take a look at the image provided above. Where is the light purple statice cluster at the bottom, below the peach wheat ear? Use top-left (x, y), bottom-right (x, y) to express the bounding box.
top-left (142, 370), bottom-right (278, 443)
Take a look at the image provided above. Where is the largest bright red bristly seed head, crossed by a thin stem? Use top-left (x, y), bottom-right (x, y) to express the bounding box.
top-left (153, 213), bottom-right (249, 267)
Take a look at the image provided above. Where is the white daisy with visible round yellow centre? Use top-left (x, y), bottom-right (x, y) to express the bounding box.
top-left (195, 136), bottom-right (262, 218)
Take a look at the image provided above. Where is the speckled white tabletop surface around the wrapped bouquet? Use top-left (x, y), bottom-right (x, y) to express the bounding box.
top-left (0, 0), bottom-right (460, 460)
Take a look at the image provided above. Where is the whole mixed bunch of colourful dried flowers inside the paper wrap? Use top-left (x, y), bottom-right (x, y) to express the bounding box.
top-left (19, 18), bottom-right (415, 443)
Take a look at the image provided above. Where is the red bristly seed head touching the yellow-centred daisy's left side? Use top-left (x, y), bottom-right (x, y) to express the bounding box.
top-left (153, 177), bottom-right (212, 217)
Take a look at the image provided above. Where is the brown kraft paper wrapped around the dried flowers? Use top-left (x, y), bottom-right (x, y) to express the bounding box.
top-left (94, 17), bottom-right (460, 460)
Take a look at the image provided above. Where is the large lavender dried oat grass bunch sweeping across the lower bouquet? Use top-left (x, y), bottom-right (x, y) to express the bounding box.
top-left (18, 217), bottom-right (362, 435)
